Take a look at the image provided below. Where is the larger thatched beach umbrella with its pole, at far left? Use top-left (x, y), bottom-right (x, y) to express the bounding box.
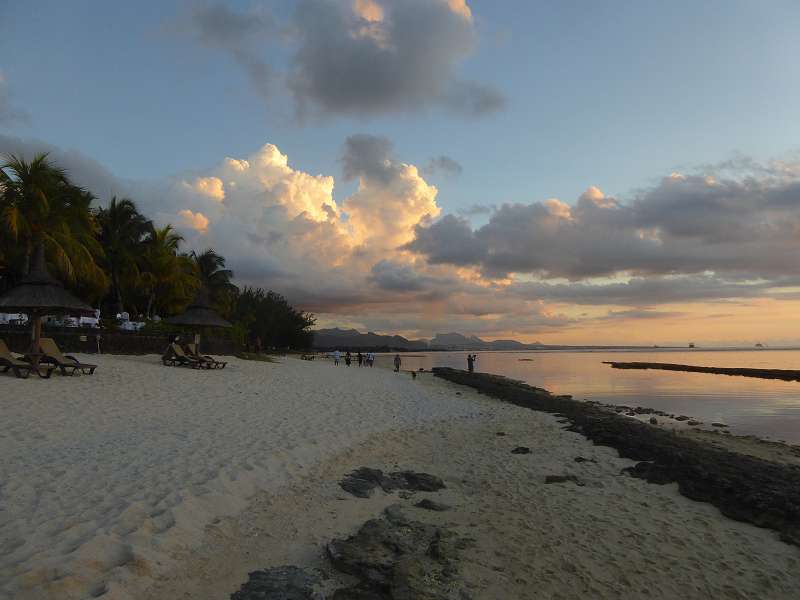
top-left (0, 244), bottom-right (94, 362)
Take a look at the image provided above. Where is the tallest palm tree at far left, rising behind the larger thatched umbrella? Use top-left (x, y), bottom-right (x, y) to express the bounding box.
top-left (0, 154), bottom-right (107, 295)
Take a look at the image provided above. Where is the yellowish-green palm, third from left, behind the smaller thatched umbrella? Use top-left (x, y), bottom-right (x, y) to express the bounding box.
top-left (139, 225), bottom-right (200, 317)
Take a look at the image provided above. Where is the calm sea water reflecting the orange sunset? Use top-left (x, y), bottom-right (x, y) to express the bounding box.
top-left (376, 350), bottom-right (800, 444)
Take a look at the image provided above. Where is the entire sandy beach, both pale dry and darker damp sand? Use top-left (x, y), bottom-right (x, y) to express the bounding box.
top-left (0, 355), bottom-right (800, 600)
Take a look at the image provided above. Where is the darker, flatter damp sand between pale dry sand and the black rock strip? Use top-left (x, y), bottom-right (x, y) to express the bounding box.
top-left (137, 373), bottom-right (800, 600)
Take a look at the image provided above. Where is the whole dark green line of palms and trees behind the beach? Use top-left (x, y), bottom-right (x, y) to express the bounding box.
top-left (0, 154), bottom-right (315, 348)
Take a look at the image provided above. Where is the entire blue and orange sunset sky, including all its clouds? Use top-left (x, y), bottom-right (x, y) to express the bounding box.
top-left (0, 0), bottom-right (800, 345)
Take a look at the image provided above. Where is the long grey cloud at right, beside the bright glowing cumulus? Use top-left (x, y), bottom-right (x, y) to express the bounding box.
top-left (407, 168), bottom-right (800, 280)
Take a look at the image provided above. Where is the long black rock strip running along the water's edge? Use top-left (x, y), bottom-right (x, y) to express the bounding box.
top-left (433, 368), bottom-right (800, 546)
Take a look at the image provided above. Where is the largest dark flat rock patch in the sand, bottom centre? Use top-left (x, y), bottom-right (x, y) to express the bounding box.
top-left (327, 506), bottom-right (468, 600)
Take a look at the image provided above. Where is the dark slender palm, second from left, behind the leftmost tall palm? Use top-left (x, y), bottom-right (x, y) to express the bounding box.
top-left (97, 196), bottom-right (152, 313)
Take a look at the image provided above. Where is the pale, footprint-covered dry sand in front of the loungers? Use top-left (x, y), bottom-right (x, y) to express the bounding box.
top-left (0, 356), bottom-right (479, 600)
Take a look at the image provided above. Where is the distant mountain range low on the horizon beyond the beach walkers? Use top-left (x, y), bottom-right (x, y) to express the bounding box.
top-left (313, 328), bottom-right (668, 352)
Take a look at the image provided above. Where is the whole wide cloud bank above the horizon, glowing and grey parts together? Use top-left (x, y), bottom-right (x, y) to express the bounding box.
top-left (6, 128), bottom-right (800, 339)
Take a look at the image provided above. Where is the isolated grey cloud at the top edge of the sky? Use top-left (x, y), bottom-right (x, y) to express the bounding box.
top-left (172, 0), bottom-right (505, 116)
